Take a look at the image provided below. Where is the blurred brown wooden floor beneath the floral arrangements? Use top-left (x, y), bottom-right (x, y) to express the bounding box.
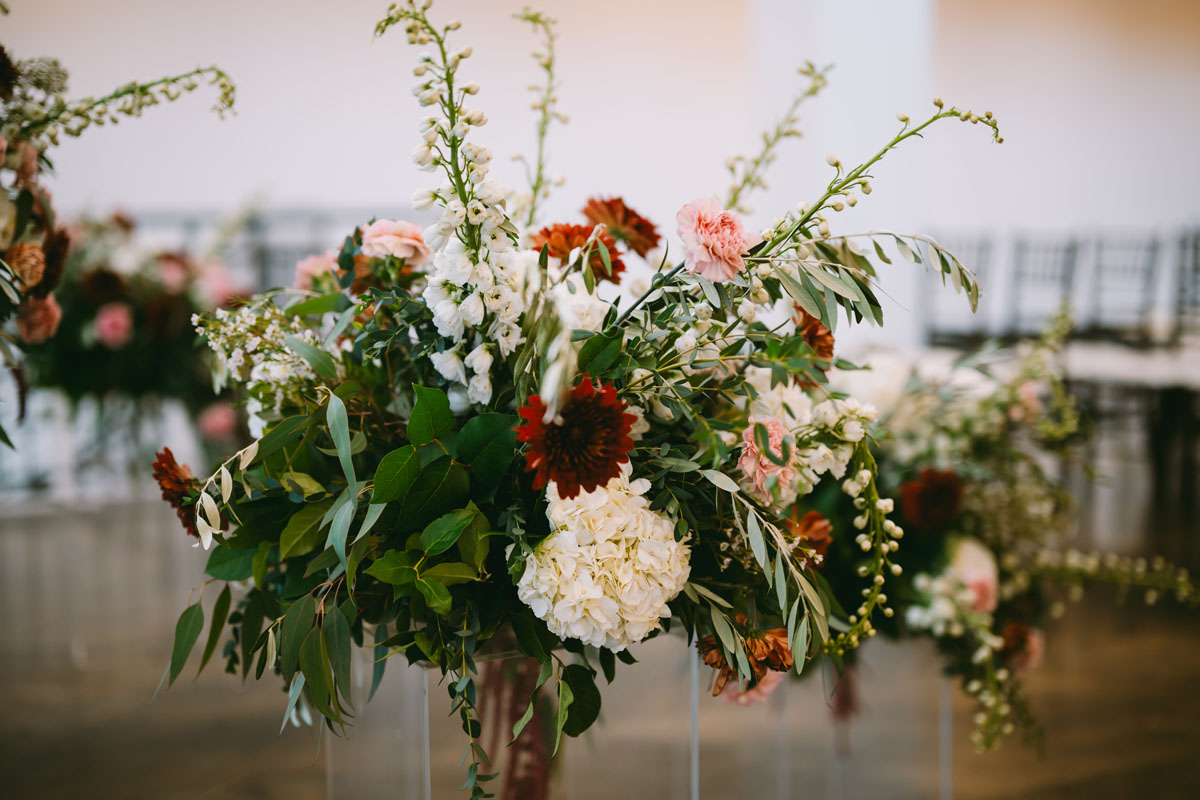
top-left (0, 504), bottom-right (1200, 800)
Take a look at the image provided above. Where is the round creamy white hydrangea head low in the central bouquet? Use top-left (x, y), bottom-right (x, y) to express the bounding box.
top-left (517, 463), bottom-right (691, 651)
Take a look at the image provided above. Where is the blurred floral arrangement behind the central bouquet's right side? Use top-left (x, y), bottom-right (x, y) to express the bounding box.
top-left (818, 314), bottom-right (1200, 751)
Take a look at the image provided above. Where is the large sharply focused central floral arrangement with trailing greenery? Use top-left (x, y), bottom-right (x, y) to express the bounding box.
top-left (155, 1), bottom-right (998, 796)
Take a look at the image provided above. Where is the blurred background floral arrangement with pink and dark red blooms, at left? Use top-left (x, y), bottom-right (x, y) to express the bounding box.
top-left (29, 213), bottom-right (248, 446)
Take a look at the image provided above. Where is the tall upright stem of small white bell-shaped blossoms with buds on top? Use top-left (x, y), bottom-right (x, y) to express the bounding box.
top-left (409, 32), bottom-right (536, 405)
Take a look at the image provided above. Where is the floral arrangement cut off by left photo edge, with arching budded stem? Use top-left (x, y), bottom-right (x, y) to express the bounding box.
top-left (0, 21), bottom-right (234, 446)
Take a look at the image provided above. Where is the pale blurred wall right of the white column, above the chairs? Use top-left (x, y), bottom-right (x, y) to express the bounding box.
top-left (930, 0), bottom-right (1200, 229)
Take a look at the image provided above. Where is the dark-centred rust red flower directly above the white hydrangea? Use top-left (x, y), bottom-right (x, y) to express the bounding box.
top-left (517, 375), bottom-right (637, 499)
